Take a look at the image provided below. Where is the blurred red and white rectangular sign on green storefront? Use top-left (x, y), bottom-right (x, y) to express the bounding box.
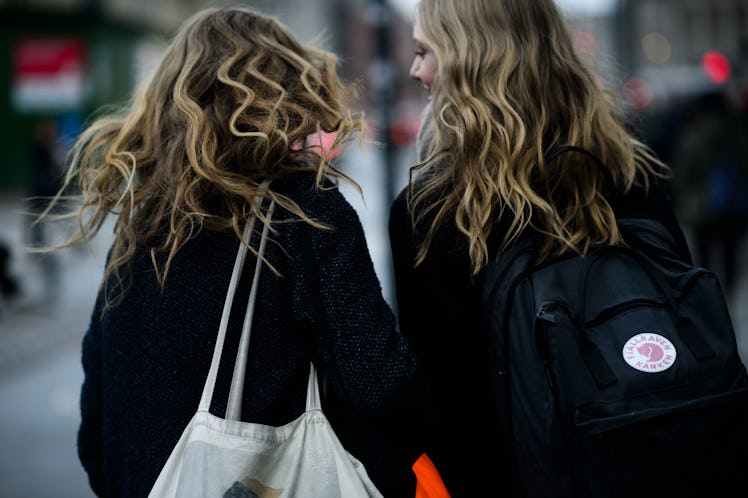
top-left (12, 38), bottom-right (85, 111)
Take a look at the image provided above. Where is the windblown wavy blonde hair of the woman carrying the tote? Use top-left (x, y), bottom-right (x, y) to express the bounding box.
top-left (46, 8), bottom-right (364, 296)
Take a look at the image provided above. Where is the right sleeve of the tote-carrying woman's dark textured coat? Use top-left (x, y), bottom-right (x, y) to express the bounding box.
top-left (289, 184), bottom-right (428, 498)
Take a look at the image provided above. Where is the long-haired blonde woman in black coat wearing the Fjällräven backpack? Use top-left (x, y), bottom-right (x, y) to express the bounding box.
top-left (390, 0), bottom-right (690, 497)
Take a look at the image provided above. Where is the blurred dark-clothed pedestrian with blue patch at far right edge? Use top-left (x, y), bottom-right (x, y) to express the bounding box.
top-left (673, 90), bottom-right (748, 294)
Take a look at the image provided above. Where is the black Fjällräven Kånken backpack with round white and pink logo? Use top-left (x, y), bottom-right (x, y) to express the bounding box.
top-left (483, 147), bottom-right (748, 498)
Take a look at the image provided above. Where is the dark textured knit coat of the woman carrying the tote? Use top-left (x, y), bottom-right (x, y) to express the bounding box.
top-left (78, 173), bottom-right (422, 498)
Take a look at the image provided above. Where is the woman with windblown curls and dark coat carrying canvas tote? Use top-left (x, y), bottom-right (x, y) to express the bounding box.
top-left (41, 8), bottom-right (421, 497)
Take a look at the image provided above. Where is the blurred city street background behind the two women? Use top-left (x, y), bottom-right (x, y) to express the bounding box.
top-left (0, 0), bottom-right (748, 498)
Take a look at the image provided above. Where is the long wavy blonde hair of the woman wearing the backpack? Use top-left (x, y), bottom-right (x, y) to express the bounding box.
top-left (408, 0), bottom-right (668, 275)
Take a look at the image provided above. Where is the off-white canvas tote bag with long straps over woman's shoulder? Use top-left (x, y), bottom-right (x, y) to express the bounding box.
top-left (149, 194), bottom-right (382, 498)
